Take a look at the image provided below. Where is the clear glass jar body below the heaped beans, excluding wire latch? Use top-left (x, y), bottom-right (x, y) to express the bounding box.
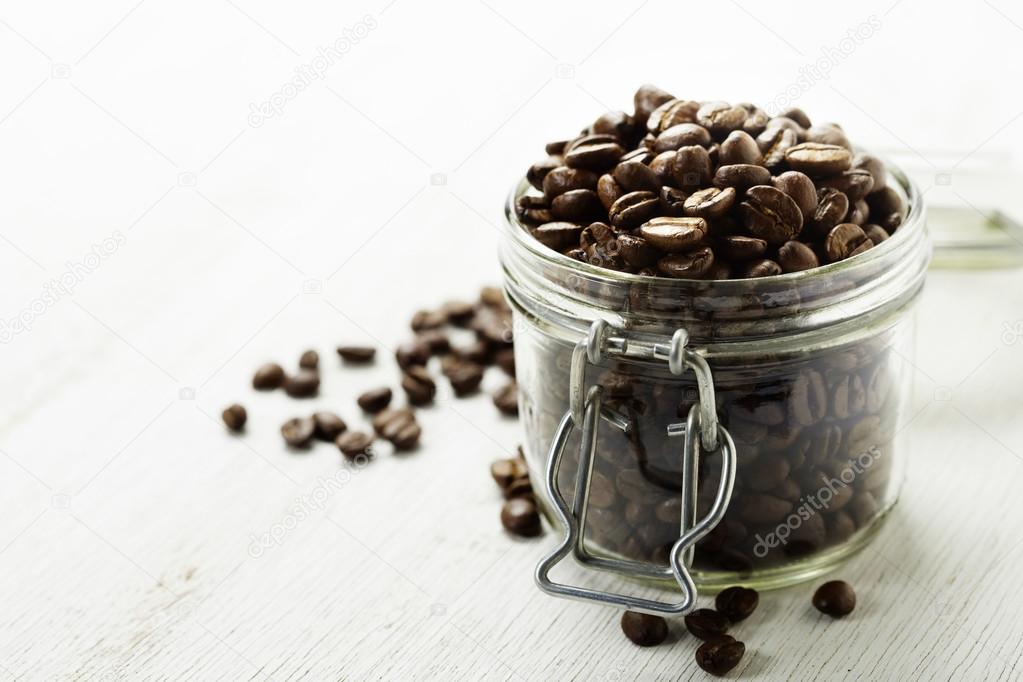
top-left (501, 162), bottom-right (930, 589)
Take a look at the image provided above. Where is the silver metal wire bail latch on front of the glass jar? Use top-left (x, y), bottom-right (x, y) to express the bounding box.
top-left (535, 320), bottom-right (736, 615)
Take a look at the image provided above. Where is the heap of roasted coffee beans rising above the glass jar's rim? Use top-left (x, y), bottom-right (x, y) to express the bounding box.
top-left (516, 85), bottom-right (905, 279)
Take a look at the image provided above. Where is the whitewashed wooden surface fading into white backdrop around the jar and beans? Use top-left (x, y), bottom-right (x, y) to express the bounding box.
top-left (0, 0), bottom-right (1023, 680)
